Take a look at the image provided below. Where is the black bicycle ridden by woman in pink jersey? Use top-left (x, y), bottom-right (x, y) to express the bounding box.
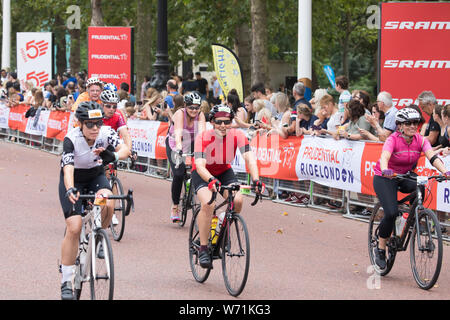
top-left (368, 173), bottom-right (448, 290)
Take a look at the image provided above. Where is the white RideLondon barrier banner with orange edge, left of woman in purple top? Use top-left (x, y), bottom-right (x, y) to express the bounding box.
top-left (127, 120), bottom-right (168, 159)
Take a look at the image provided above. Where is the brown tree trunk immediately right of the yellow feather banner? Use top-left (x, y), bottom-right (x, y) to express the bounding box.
top-left (234, 23), bottom-right (252, 98)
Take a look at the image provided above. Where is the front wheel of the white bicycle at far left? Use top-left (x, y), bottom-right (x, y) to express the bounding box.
top-left (90, 229), bottom-right (114, 300)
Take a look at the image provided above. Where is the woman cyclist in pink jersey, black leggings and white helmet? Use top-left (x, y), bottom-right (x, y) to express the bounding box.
top-left (373, 108), bottom-right (450, 269)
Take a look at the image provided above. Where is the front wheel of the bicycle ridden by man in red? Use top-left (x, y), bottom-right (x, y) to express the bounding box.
top-left (221, 214), bottom-right (250, 297)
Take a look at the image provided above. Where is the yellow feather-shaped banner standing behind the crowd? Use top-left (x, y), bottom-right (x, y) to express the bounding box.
top-left (211, 44), bottom-right (244, 102)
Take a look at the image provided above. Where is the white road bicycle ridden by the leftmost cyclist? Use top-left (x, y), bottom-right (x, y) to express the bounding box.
top-left (60, 190), bottom-right (134, 300)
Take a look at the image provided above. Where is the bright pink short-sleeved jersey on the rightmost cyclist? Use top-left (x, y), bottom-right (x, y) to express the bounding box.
top-left (374, 132), bottom-right (432, 176)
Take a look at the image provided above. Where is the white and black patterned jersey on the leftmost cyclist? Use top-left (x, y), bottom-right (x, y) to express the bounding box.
top-left (61, 126), bottom-right (122, 181)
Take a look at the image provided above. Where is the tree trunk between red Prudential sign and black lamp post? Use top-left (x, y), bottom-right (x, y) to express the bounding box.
top-left (134, 0), bottom-right (153, 100)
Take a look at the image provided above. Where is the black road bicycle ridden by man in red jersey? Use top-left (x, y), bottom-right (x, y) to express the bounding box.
top-left (189, 184), bottom-right (262, 297)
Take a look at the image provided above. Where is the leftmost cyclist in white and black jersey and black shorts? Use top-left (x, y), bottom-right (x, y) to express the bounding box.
top-left (59, 101), bottom-right (130, 300)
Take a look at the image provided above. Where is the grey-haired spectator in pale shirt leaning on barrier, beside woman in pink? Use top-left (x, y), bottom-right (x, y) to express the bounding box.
top-left (366, 91), bottom-right (398, 141)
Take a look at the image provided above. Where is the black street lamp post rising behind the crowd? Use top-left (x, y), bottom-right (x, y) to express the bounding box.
top-left (149, 0), bottom-right (170, 91)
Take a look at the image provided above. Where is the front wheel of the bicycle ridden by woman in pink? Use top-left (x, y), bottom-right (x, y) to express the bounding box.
top-left (410, 209), bottom-right (443, 290)
